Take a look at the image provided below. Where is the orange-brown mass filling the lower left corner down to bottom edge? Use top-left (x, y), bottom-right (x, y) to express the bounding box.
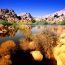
top-left (0, 40), bottom-right (16, 65)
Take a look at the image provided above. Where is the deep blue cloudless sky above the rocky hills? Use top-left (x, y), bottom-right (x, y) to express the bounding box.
top-left (0, 0), bottom-right (65, 17)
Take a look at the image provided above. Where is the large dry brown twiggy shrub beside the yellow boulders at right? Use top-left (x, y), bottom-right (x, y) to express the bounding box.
top-left (33, 29), bottom-right (57, 58)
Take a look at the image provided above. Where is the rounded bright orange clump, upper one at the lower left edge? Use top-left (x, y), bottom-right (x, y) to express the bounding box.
top-left (0, 40), bottom-right (16, 55)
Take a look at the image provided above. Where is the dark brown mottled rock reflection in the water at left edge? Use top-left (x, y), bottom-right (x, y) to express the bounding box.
top-left (0, 25), bottom-right (16, 38)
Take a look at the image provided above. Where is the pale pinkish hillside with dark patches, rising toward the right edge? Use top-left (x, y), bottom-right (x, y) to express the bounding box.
top-left (35, 9), bottom-right (65, 24)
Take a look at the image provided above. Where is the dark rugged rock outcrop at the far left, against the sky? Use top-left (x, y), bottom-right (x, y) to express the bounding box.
top-left (0, 9), bottom-right (19, 22)
